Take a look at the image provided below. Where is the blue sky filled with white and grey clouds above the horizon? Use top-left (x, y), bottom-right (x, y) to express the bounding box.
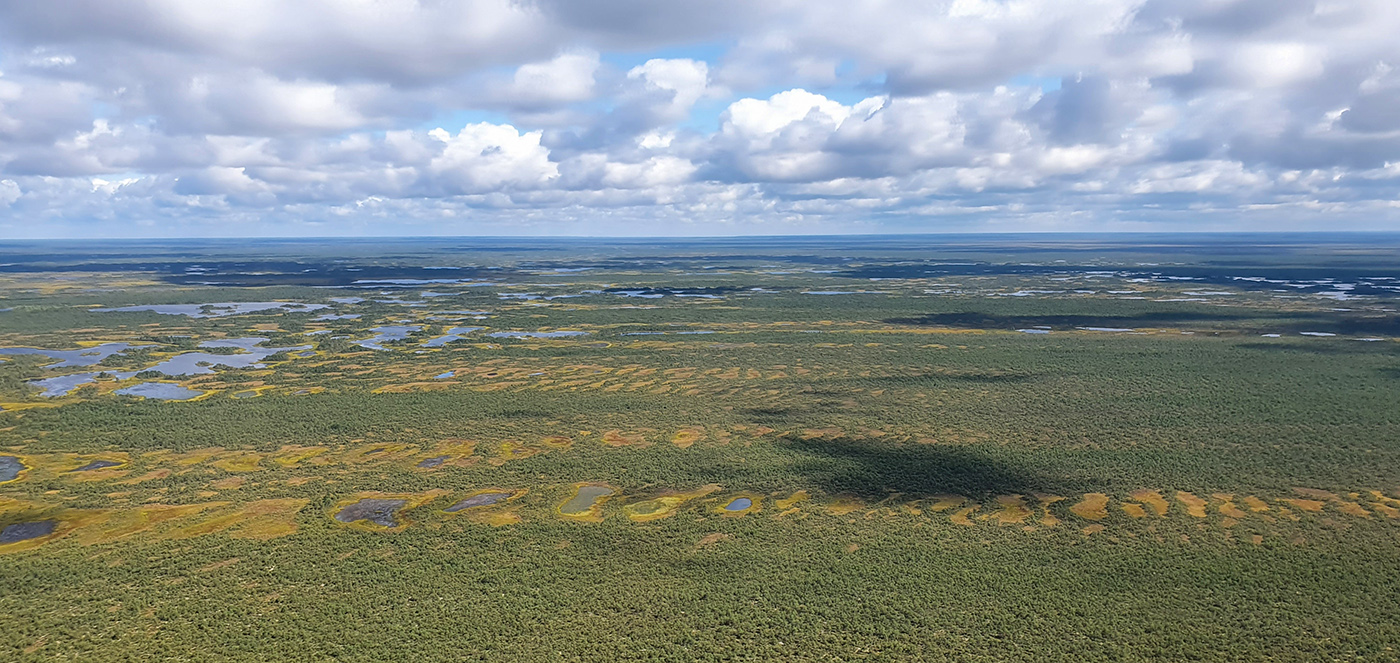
top-left (0, 0), bottom-right (1400, 239)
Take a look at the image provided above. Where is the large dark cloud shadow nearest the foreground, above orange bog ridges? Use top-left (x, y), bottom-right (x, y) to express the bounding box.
top-left (784, 438), bottom-right (1058, 498)
